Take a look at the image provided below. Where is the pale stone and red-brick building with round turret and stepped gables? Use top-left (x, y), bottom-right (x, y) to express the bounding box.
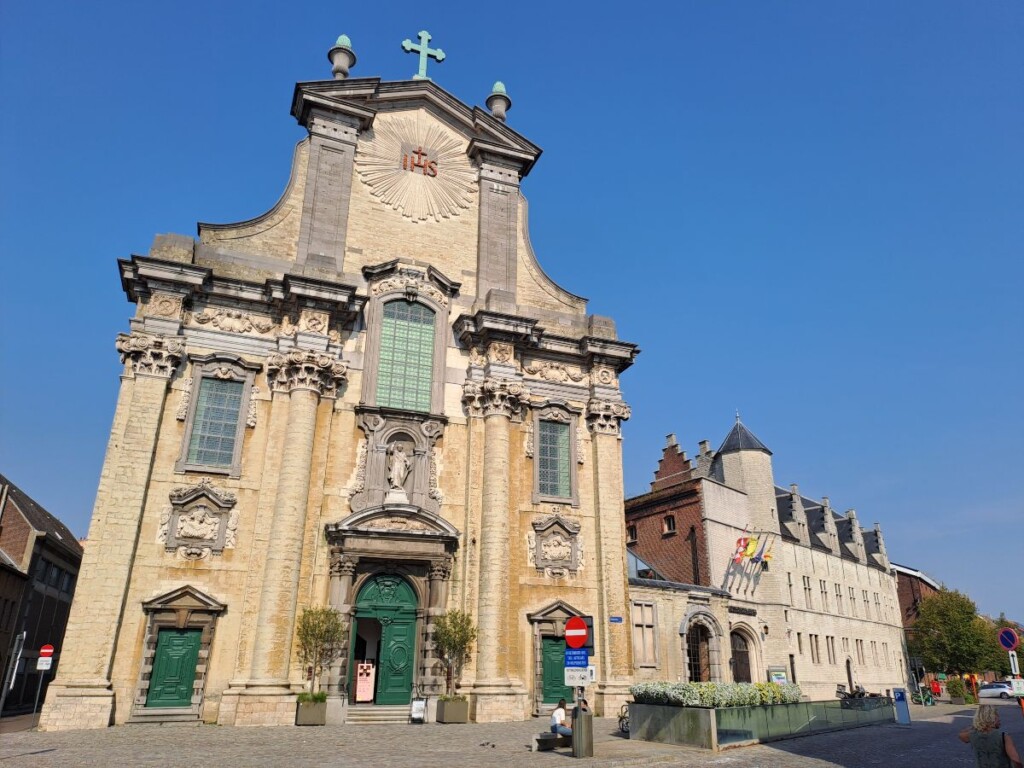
top-left (626, 417), bottom-right (907, 700)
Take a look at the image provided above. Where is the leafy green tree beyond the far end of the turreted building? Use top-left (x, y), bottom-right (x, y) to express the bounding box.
top-left (909, 588), bottom-right (994, 674)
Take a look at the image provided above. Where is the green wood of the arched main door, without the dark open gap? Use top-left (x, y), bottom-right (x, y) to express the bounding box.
top-left (355, 573), bottom-right (417, 705)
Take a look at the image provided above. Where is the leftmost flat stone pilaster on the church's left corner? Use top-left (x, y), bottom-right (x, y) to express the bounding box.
top-left (39, 333), bottom-right (184, 730)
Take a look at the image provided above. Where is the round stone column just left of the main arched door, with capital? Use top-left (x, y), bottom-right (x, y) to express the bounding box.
top-left (224, 349), bottom-right (346, 725)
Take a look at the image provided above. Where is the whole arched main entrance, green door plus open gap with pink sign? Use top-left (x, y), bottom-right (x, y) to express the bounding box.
top-left (348, 573), bottom-right (417, 705)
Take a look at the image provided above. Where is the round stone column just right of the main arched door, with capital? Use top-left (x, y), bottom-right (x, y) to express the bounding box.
top-left (463, 379), bottom-right (528, 722)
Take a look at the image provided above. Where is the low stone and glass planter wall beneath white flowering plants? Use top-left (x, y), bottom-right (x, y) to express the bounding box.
top-left (630, 697), bottom-right (895, 752)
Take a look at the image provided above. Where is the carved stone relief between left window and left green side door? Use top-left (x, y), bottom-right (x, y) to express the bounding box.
top-left (157, 477), bottom-right (239, 560)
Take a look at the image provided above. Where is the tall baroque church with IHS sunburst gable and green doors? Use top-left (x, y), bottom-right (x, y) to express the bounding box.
top-left (40, 38), bottom-right (638, 730)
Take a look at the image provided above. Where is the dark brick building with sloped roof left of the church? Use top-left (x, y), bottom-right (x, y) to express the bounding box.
top-left (0, 475), bottom-right (82, 715)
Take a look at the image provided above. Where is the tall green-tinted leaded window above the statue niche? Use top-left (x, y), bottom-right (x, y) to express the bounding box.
top-left (377, 299), bottom-right (434, 412)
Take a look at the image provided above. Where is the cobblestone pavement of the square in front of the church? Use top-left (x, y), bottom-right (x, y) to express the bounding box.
top-left (0, 703), bottom-right (1024, 768)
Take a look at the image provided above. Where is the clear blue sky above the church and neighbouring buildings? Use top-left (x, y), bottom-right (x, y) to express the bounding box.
top-left (0, 0), bottom-right (1024, 621)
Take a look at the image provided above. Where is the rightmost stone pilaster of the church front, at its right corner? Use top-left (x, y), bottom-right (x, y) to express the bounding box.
top-left (587, 399), bottom-right (633, 717)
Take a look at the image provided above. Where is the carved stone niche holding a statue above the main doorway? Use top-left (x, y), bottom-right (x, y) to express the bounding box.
top-left (349, 409), bottom-right (444, 513)
